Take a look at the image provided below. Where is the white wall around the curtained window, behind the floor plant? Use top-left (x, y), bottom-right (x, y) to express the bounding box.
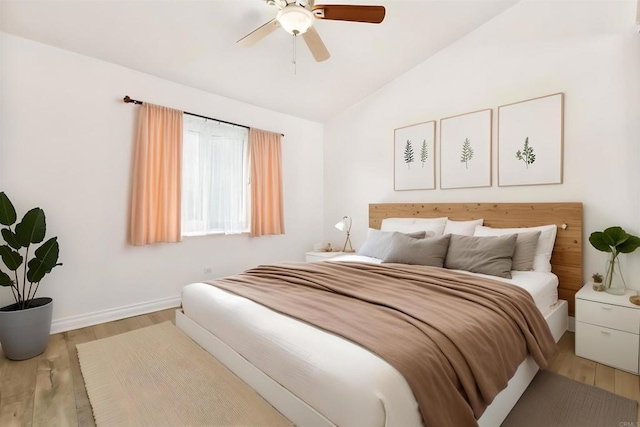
top-left (0, 33), bottom-right (323, 328)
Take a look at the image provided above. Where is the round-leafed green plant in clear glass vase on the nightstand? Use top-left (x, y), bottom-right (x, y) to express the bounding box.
top-left (589, 226), bottom-right (640, 295)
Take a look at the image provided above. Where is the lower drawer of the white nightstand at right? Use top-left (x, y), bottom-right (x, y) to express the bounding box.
top-left (576, 322), bottom-right (640, 374)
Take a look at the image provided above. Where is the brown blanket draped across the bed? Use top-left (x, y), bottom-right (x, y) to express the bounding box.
top-left (209, 262), bottom-right (557, 427)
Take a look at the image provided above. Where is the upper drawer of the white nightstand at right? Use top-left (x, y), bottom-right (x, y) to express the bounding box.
top-left (576, 299), bottom-right (640, 334)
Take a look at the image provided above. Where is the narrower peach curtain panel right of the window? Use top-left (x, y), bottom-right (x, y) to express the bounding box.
top-left (249, 128), bottom-right (284, 236)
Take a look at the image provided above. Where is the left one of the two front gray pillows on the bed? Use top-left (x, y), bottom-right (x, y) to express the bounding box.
top-left (382, 233), bottom-right (451, 267)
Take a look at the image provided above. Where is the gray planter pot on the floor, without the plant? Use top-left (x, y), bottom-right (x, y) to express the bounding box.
top-left (0, 297), bottom-right (53, 360)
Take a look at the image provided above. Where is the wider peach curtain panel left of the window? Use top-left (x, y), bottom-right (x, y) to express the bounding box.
top-left (130, 103), bottom-right (182, 246)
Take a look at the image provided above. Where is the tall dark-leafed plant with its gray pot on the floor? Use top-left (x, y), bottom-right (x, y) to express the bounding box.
top-left (0, 192), bottom-right (62, 360)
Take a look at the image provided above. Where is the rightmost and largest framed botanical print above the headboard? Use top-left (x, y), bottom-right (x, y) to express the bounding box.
top-left (498, 93), bottom-right (564, 186)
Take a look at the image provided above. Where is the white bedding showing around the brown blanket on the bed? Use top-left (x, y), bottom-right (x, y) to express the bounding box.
top-left (182, 255), bottom-right (557, 427)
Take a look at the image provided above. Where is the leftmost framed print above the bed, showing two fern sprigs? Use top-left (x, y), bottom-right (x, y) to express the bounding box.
top-left (393, 120), bottom-right (436, 191)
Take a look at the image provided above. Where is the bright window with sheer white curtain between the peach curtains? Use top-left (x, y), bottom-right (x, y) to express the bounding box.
top-left (181, 114), bottom-right (250, 236)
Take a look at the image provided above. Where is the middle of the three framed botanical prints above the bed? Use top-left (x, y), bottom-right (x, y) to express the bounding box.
top-left (440, 108), bottom-right (493, 190)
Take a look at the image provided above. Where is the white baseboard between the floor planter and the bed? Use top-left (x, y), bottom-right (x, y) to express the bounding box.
top-left (51, 295), bottom-right (182, 334)
